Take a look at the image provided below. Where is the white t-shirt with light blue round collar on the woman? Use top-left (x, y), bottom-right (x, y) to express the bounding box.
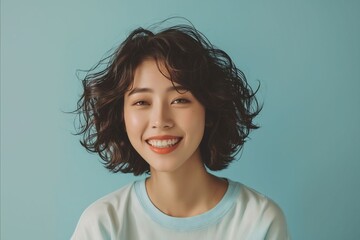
top-left (71, 180), bottom-right (290, 240)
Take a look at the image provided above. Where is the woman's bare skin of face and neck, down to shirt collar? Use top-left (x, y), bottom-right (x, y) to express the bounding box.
top-left (124, 59), bottom-right (227, 217)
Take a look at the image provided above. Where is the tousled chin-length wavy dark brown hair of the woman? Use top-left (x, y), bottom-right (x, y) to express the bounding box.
top-left (74, 25), bottom-right (262, 175)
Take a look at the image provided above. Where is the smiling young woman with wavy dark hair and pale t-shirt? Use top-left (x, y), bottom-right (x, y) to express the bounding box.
top-left (72, 25), bottom-right (289, 240)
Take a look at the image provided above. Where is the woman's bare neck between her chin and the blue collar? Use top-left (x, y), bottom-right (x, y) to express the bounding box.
top-left (146, 158), bottom-right (227, 217)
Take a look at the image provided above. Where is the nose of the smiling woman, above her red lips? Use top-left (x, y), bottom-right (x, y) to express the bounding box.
top-left (150, 103), bottom-right (174, 129)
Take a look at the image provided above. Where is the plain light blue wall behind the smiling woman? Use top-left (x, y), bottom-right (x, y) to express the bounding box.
top-left (1, 0), bottom-right (360, 240)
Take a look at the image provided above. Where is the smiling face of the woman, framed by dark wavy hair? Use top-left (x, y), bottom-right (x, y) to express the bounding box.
top-left (124, 59), bottom-right (205, 172)
